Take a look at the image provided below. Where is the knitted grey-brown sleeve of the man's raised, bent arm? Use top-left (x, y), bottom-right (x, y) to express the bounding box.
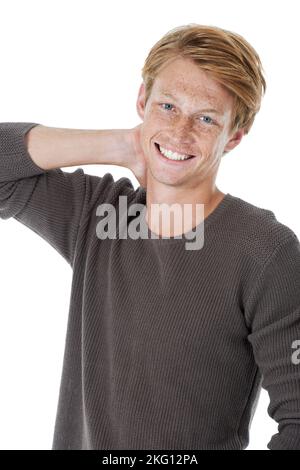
top-left (0, 122), bottom-right (130, 266)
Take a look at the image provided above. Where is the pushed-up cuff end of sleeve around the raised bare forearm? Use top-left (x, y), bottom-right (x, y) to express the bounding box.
top-left (0, 122), bottom-right (45, 183)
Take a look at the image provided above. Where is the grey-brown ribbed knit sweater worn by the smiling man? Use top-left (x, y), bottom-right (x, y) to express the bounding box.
top-left (0, 122), bottom-right (300, 450)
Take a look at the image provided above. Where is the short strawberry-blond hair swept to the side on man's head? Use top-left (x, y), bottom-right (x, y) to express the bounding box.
top-left (142, 23), bottom-right (266, 134)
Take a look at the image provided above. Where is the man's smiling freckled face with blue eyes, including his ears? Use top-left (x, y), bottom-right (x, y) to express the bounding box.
top-left (137, 58), bottom-right (244, 189)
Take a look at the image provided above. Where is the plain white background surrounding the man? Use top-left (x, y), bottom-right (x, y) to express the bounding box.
top-left (0, 0), bottom-right (300, 450)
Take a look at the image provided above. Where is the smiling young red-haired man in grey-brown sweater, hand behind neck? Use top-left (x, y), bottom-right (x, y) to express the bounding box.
top-left (0, 25), bottom-right (300, 450)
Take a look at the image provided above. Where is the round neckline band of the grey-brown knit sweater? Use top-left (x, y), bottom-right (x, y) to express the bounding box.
top-left (138, 189), bottom-right (235, 243)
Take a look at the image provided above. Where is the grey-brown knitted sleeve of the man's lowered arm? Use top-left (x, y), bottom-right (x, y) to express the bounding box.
top-left (245, 231), bottom-right (300, 450)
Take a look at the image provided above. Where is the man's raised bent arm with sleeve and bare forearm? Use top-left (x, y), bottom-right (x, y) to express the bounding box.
top-left (0, 122), bottom-right (142, 265)
